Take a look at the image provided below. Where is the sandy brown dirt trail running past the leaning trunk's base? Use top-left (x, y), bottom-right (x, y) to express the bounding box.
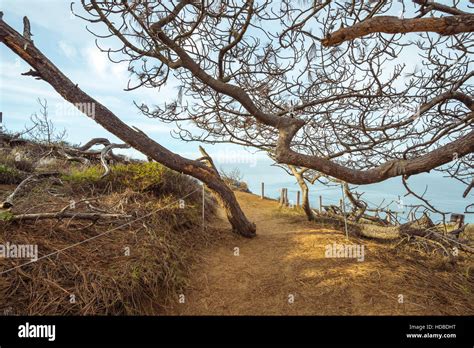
top-left (167, 192), bottom-right (474, 315)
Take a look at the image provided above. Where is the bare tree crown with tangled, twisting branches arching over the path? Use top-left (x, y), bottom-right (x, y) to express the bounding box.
top-left (68, 0), bottom-right (474, 192)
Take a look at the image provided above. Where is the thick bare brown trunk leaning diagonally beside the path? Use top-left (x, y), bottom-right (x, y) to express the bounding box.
top-left (0, 19), bottom-right (256, 237)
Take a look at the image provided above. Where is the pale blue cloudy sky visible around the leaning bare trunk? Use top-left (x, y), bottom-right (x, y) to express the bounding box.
top-left (0, 0), bottom-right (472, 220)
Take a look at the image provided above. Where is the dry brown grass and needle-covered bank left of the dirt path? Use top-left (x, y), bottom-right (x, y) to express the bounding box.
top-left (0, 163), bottom-right (220, 315)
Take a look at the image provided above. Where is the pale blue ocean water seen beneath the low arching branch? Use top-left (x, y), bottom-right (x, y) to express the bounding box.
top-left (216, 160), bottom-right (474, 223)
